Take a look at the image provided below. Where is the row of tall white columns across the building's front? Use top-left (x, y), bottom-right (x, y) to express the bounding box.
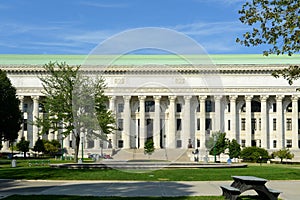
top-left (4, 94), bottom-right (299, 152)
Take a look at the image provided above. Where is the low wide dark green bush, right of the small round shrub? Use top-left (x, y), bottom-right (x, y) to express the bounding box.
top-left (241, 147), bottom-right (269, 162)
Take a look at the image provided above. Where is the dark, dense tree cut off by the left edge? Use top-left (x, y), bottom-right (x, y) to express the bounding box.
top-left (0, 69), bottom-right (22, 149)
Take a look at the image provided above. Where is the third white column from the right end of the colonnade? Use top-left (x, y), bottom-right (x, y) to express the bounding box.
top-left (260, 95), bottom-right (269, 149)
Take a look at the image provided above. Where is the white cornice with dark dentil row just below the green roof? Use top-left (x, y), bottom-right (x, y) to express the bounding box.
top-left (0, 64), bottom-right (296, 75)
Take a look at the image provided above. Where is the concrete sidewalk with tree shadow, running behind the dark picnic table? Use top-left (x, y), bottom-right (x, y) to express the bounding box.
top-left (0, 180), bottom-right (300, 200)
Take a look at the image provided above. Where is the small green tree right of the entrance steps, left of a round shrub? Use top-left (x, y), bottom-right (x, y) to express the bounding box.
top-left (206, 131), bottom-right (227, 155)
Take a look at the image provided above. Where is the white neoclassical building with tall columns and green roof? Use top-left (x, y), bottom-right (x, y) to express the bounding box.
top-left (0, 55), bottom-right (300, 159)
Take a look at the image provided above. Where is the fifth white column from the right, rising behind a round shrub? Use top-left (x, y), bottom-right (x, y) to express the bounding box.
top-left (229, 95), bottom-right (240, 141)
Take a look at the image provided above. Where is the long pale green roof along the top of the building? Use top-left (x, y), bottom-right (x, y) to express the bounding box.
top-left (0, 54), bottom-right (300, 65)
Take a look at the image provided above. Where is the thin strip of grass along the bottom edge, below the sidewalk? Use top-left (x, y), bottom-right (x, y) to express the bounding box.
top-left (4, 195), bottom-right (268, 200)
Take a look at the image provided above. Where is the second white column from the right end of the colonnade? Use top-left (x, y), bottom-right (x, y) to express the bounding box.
top-left (276, 95), bottom-right (284, 149)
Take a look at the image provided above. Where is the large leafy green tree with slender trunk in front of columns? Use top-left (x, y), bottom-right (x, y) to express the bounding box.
top-left (37, 62), bottom-right (114, 162)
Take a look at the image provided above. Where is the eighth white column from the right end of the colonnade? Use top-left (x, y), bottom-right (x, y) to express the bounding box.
top-left (182, 96), bottom-right (193, 149)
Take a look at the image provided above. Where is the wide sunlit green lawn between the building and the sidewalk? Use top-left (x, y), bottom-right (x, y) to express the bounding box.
top-left (0, 160), bottom-right (300, 181)
